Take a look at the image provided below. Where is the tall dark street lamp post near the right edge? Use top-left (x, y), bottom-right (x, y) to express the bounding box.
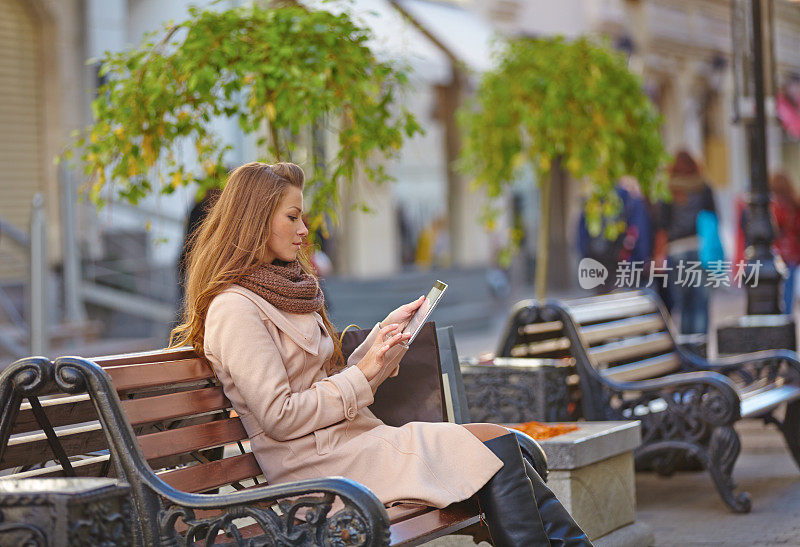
top-left (731, 0), bottom-right (783, 315)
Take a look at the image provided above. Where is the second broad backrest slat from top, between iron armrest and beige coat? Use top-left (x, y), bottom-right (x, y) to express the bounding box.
top-left (122, 386), bottom-right (231, 425)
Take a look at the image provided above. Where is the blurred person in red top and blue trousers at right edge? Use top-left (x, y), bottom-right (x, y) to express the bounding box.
top-left (769, 173), bottom-right (800, 313)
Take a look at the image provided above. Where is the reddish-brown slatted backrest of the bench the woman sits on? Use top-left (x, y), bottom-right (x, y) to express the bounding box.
top-left (0, 350), bottom-right (238, 492)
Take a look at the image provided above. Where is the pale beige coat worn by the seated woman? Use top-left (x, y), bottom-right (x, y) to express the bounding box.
top-left (204, 285), bottom-right (502, 507)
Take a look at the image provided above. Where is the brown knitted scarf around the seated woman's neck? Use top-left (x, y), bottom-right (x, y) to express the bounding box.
top-left (238, 260), bottom-right (325, 313)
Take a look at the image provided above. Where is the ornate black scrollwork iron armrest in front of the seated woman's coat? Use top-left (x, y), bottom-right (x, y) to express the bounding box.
top-left (55, 357), bottom-right (389, 545)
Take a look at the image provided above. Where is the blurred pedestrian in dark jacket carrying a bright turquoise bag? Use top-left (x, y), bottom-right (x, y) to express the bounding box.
top-left (654, 150), bottom-right (719, 334)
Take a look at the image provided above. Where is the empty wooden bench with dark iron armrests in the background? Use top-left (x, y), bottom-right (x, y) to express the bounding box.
top-left (498, 290), bottom-right (800, 512)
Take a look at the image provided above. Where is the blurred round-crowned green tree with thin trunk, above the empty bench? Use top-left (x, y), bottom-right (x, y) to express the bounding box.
top-left (460, 37), bottom-right (668, 298)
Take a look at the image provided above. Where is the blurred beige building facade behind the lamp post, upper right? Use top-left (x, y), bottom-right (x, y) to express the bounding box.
top-left (475, 0), bottom-right (800, 262)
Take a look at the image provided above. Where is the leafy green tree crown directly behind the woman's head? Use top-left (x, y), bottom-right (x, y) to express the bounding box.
top-left (64, 5), bottom-right (420, 238)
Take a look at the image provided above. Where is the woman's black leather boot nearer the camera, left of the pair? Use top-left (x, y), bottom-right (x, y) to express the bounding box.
top-left (478, 434), bottom-right (550, 547)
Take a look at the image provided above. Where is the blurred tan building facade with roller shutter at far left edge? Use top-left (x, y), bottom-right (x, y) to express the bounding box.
top-left (0, 0), bottom-right (88, 283)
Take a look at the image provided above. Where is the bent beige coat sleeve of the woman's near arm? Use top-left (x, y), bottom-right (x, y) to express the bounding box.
top-left (205, 293), bottom-right (373, 441)
